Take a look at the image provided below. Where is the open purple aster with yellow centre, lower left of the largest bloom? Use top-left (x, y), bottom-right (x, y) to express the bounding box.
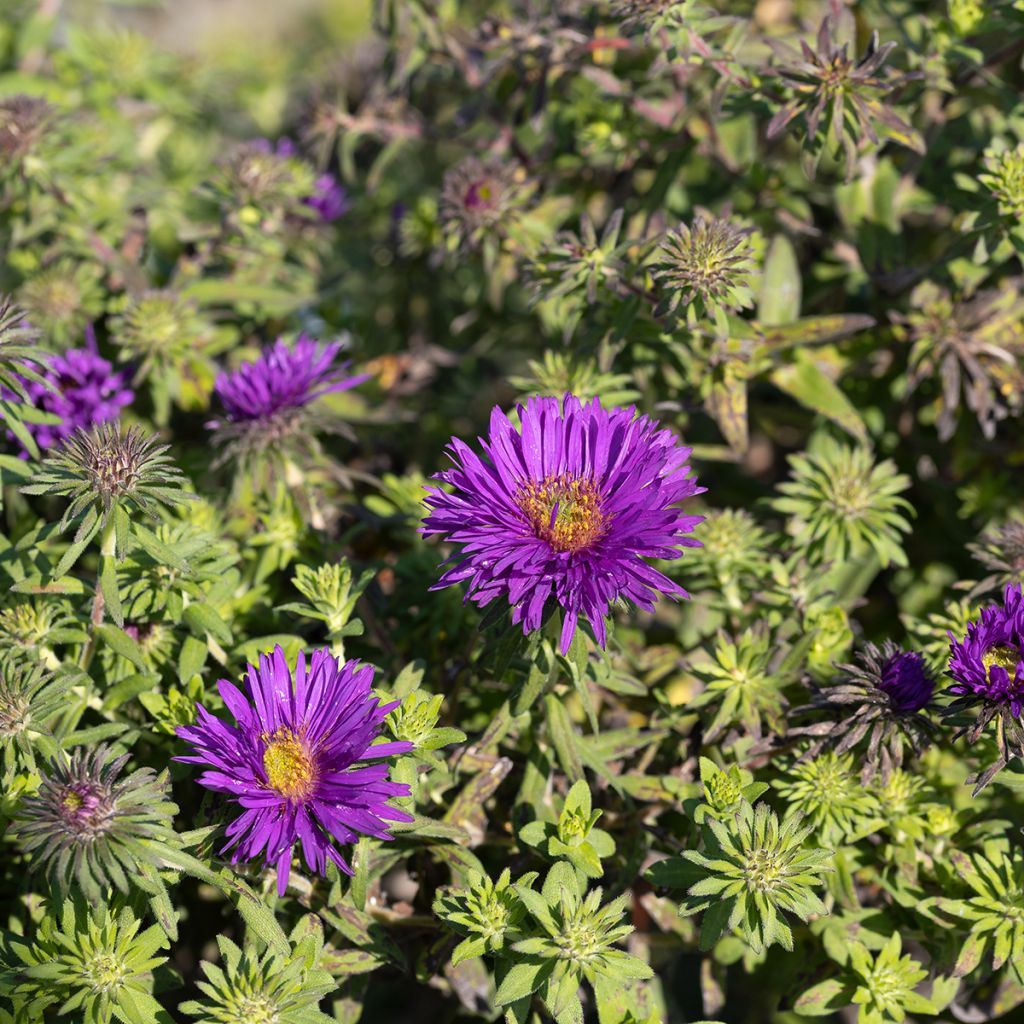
top-left (177, 646), bottom-right (413, 895)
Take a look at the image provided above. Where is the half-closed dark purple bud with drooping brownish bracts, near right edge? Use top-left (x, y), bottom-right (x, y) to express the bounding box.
top-left (790, 640), bottom-right (935, 782)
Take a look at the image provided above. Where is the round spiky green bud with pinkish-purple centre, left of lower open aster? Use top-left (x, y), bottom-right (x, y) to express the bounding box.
top-left (15, 746), bottom-right (177, 902)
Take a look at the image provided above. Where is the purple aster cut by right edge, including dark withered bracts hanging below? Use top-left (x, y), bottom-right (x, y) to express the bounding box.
top-left (943, 584), bottom-right (1024, 794)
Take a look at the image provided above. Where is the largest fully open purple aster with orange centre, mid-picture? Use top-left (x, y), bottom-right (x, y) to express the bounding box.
top-left (422, 394), bottom-right (705, 653)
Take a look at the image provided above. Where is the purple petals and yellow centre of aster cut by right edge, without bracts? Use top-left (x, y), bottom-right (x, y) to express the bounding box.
top-left (948, 584), bottom-right (1024, 719)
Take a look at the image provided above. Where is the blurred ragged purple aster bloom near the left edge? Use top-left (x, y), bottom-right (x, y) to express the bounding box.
top-left (3, 328), bottom-right (135, 450)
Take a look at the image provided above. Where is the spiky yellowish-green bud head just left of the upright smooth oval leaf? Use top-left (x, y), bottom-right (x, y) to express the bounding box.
top-left (653, 215), bottom-right (754, 333)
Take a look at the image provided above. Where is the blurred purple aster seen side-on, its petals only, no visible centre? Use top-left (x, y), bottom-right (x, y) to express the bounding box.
top-left (214, 335), bottom-right (368, 423)
